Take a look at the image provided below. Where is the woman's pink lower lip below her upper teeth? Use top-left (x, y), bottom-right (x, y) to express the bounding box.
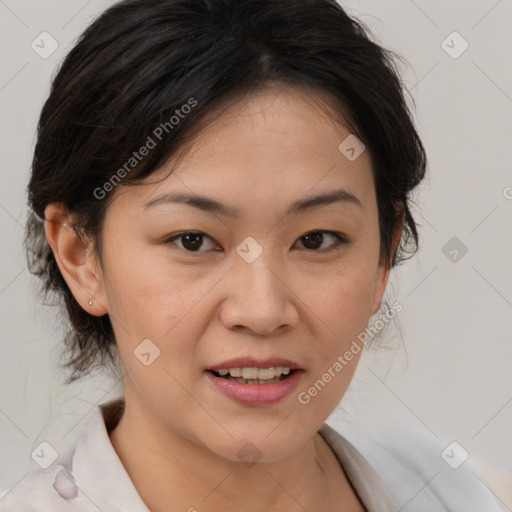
top-left (205, 370), bottom-right (302, 406)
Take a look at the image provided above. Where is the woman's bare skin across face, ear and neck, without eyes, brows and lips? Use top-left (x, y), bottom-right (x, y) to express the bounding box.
top-left (45, 87), bottom-right (401, 512)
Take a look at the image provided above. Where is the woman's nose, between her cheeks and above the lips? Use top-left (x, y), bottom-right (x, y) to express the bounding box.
top-left (220, 254), bottom-right (299, 336)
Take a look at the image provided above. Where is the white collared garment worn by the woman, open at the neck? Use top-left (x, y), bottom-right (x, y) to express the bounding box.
top-left (0, 398), bottom-right (503, 512)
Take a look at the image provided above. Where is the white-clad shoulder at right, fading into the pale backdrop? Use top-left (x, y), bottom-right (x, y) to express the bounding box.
top-left (324, 426), bottom-right (503, 512)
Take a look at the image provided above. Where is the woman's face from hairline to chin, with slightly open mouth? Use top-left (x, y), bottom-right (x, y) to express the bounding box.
top-left (97, 88), bottom-right (394, 461)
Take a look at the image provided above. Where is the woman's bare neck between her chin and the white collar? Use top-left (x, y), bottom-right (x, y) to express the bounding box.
top-left (110, 394), bottom-right (356, 512)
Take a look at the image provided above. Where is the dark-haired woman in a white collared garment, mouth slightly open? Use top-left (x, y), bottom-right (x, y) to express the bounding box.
top-left (0, 0), bottom-right (500, 512)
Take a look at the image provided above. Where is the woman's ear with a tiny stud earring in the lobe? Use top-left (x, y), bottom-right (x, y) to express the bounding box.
top-left (44, 203), bottom-right (107, 316)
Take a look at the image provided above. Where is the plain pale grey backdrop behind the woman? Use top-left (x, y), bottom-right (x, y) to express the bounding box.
top-left (0, 0), bottom-right (512, 510)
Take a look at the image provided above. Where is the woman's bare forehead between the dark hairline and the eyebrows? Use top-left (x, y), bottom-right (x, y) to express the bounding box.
top-left (113, 87), bottom-right (374, 210)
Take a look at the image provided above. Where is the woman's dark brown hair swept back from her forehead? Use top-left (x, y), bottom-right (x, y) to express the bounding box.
top-left (25, 0), bottom-right (426, 382)
